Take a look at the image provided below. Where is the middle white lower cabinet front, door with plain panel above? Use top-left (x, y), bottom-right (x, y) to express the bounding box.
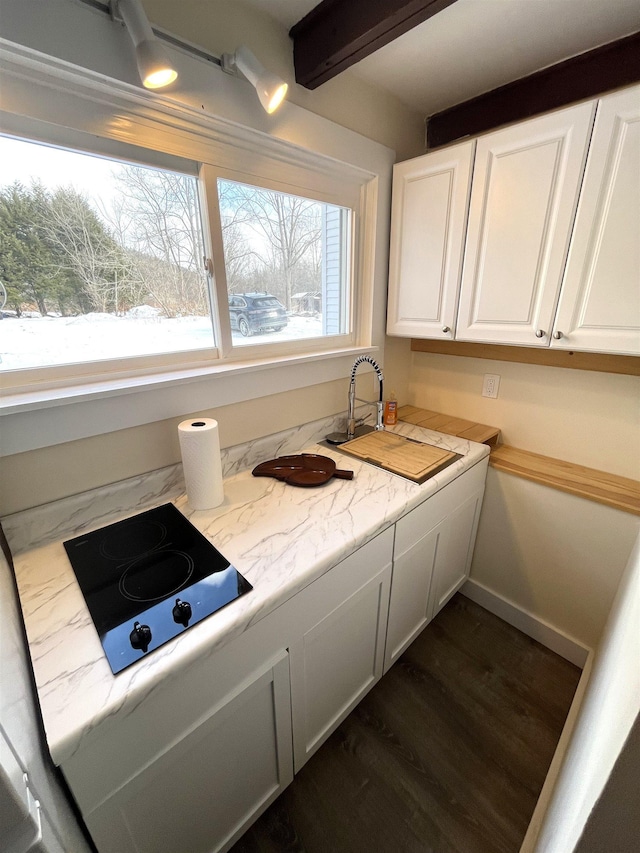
top-left (289, 530), bottom-right (393, 772)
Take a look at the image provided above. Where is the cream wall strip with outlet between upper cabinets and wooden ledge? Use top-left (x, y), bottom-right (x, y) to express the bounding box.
top-left (409, 352), bottom-right (640, 479)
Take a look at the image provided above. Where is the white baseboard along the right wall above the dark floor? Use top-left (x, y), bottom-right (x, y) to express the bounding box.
top-left (460, 579), bottom-right (591, 669)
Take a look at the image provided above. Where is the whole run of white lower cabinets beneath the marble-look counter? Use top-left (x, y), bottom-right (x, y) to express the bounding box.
top-left (62, 459), bottom-right (488, 853)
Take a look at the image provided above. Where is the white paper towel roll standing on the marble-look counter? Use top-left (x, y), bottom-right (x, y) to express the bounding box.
top-left (178, 418), bottom-right (224, 509)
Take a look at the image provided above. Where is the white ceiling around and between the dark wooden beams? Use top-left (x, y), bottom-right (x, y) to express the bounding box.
top-left (245, 0), bottom-right (640, 116)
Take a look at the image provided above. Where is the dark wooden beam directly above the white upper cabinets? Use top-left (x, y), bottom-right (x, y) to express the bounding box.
top-left (427, 32), bottom-right (640, 150)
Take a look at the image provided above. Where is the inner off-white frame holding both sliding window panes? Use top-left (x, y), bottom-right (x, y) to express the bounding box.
top-left (0, 114), bottom-right (370, 393)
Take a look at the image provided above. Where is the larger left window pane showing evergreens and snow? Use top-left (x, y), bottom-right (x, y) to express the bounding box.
top-left (0, 137), bottom-right (214, 371)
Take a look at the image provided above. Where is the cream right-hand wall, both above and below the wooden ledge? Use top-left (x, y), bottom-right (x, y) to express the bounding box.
top-left (401, 353), bottom-right (640, 648)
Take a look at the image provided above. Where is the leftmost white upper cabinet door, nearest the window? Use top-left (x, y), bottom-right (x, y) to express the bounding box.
top-left (387, 142), bottom-right (475, 340)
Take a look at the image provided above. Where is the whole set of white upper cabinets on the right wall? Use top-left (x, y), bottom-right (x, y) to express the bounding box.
top-left (387, 86), bottom-right (640, 355)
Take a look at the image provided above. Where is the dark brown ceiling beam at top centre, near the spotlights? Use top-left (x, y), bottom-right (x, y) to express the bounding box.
top-left (289, 0), bottom-right (456, 89)
